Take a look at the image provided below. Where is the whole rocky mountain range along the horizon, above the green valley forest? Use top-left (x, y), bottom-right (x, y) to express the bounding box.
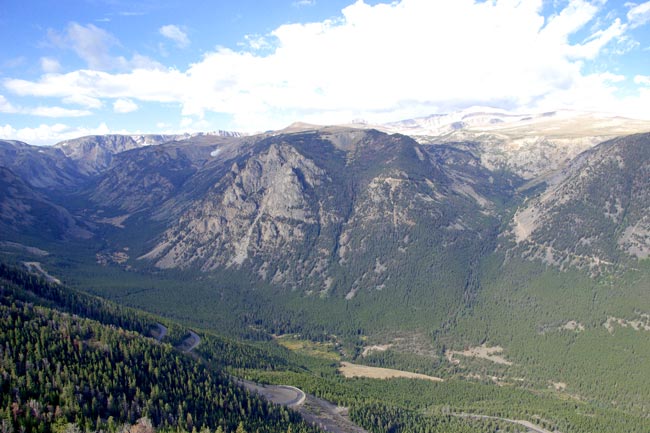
top-left (0, 109), bottom-right (650, 270)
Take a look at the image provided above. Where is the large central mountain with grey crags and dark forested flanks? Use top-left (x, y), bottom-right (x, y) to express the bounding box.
top-left (142, 127), bottom-right (513, 308)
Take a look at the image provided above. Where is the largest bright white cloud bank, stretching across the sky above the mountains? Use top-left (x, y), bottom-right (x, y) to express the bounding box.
top-left (4, 0), bottom-right (647, 131)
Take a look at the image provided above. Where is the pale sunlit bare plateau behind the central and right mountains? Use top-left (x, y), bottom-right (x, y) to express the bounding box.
top-left (384, 109), bottom-right (650, 179)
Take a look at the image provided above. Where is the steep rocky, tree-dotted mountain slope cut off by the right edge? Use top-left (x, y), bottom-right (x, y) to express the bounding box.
top-left (512, 134), bottom-right (650, 267)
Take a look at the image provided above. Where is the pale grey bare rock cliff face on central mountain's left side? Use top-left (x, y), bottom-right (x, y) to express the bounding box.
top-left (146, 144), bottom-right (328, 274)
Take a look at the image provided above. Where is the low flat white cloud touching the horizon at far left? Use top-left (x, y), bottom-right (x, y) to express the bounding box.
top-left (0, 123), bottom-right (110, 145)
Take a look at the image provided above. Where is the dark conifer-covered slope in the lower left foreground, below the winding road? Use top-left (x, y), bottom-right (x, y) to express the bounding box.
top-left (0, 265), bottom-right (316, 433)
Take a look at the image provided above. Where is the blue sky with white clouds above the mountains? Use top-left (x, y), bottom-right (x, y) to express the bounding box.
top-left (0, 0), bottom-right (650, 145)
